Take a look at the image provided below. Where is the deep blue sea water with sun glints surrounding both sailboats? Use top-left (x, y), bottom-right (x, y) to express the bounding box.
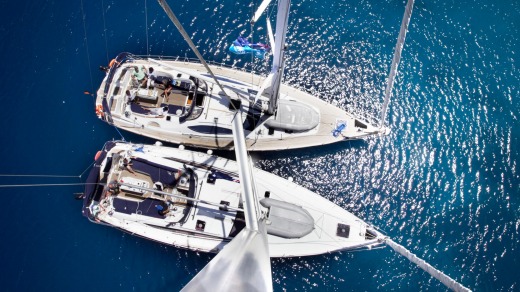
top-left (0, 0), bottom-right (520, 291)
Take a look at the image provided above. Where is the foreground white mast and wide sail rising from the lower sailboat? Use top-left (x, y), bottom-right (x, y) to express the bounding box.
top-left (183, 115), bottom-right (273, 291)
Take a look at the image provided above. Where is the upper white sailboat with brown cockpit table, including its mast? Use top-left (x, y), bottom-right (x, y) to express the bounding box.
top-left (92, 0), bottom-right (398, 151)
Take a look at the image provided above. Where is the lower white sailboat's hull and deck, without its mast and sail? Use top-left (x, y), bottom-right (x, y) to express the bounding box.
top-left (83, 142), bottom-right (382, 257)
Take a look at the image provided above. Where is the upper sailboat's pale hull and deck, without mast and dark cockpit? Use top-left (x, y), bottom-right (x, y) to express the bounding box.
top-left (96, 58), bottom-right (388, 151)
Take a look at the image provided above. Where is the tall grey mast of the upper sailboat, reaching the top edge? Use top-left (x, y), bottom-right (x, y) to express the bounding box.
top-left (266, 0), bottom-right (291, 115)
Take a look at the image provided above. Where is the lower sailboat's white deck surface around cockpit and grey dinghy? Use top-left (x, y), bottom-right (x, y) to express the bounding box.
top-left (87, 144), bottom-right (381, 257)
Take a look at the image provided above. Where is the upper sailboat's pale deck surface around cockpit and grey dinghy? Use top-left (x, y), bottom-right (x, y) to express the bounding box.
top-left (96, 60), bottom-right (388, 151)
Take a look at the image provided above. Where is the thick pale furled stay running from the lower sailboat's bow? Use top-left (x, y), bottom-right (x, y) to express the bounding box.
top-left (385, 238), bottom-right (471, 292)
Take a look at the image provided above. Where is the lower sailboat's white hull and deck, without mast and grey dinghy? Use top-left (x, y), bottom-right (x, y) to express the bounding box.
top-left (83, 143), bottom-right (383, 257)
